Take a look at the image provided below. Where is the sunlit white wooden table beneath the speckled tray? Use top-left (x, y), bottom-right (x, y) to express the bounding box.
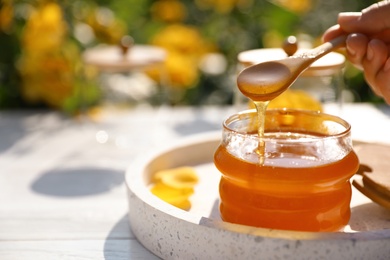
top-left (0, 104), bottom-right (390, 260)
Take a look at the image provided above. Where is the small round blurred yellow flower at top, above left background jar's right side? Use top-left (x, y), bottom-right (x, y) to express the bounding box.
top-left (151, 0), bottom-right (187, 22)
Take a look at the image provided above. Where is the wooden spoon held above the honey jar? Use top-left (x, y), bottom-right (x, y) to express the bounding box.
top-left (237, 35), bottom-right (347, 101)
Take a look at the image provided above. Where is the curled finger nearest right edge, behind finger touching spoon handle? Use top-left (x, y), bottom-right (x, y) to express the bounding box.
top-left (362, 39), bottom-right (389, 97)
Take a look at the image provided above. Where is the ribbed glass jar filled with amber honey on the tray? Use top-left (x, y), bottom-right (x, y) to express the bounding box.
top-left (214, 109), bottom-right (359, 231)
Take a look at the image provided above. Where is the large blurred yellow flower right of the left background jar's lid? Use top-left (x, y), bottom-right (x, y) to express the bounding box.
top-left (149, 24), bottom-right (213, 88)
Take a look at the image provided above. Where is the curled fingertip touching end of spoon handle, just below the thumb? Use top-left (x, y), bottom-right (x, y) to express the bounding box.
top-left (346, 33), bottom-right (369, 69)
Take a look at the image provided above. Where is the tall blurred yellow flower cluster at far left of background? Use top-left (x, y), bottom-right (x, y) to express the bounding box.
top-left (19, 2), bottom-right (78, 108)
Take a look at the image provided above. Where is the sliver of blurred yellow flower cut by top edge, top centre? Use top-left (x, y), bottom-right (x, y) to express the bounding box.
top-left (195, 0), bottom-right (253, 14)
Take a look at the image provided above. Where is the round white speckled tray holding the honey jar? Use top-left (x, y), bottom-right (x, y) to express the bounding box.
top-left (126, 132), bottom-right (390, 259)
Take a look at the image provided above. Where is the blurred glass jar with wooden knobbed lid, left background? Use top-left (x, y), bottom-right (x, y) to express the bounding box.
top-left (82, 36), bottom-right (168, 108)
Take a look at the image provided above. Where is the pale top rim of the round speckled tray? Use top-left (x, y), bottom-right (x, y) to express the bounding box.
top-left (125, 131), bottom-right (390, 258)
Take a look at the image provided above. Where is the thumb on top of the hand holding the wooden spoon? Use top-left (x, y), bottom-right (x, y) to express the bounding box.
top-left (338, 1), bottom-right (390, 35)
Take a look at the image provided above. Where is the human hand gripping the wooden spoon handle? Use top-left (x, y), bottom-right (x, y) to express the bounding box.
top-left (323, 1), bottom-right (390, 105)
